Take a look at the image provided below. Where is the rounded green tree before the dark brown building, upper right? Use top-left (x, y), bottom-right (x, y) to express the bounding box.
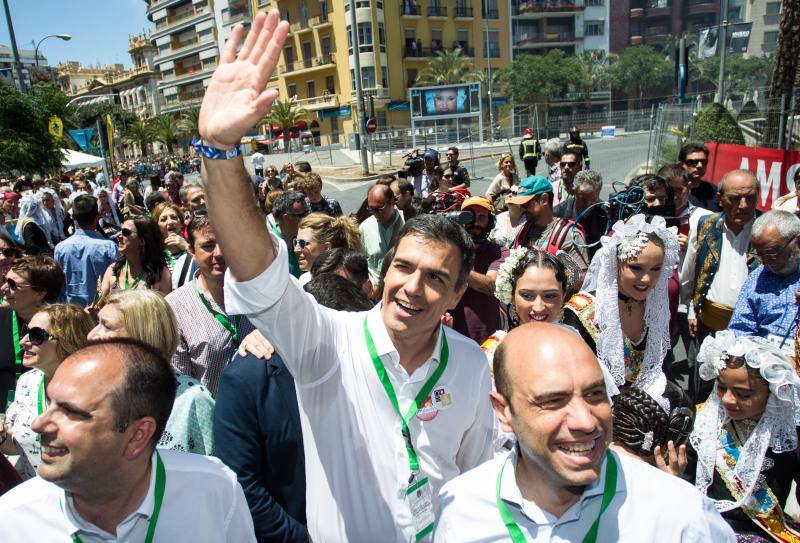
top-left (608, 45), bottom-right (675, 108)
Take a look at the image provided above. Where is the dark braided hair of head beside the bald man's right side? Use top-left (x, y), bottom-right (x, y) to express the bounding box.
top-left (611, 383), bottom-right (694, 456)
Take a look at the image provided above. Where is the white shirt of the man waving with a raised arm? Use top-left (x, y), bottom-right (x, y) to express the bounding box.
top-left (225, 234), bottom-right (493, 543)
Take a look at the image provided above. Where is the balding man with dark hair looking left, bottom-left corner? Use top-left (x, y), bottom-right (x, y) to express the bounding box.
top-left (0, 338), bottom-right (255, 543)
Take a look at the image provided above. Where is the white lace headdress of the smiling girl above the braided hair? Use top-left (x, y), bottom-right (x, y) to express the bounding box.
top-left (584, 215), bottom-right (678, 409)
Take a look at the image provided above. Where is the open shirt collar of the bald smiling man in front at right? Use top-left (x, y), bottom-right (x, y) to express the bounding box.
top-left (500, 445), bottom-right (625, 525)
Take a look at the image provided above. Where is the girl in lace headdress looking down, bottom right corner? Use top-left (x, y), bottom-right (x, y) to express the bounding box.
top-left (689, 330), bottom-right (800, 542)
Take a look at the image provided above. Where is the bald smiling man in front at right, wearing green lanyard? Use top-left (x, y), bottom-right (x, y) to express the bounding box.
top-left (434, 323), bottom-right (736, 543)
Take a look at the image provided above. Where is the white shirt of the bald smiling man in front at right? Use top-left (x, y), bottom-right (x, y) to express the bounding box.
top-left (434, 449), bottom-right (736, 543)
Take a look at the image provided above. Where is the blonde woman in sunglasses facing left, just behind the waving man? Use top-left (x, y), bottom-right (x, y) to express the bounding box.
top-left (293, 213), bottom-right (362, 285)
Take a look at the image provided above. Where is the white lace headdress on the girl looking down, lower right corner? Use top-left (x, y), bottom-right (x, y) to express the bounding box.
top-left (689, 330), bottom-right (800, 511)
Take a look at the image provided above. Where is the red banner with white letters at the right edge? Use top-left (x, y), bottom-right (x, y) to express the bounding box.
top-left (705, 142), bottom-right (800, 211)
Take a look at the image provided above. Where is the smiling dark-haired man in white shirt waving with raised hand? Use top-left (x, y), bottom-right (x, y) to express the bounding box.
top-left (199, 10), bottom-right (493, 542)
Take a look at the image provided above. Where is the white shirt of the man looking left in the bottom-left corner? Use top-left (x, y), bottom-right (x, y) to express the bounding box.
top-left (0, 449), bottom-right (256, 543)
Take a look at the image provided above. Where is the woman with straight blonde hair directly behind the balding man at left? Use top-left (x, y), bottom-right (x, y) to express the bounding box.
top-left (89, 289), bottom-right (214, 455)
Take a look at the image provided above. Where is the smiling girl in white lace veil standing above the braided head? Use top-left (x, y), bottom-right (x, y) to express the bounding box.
top-left (563, 215), bottom-right (678, 406)
